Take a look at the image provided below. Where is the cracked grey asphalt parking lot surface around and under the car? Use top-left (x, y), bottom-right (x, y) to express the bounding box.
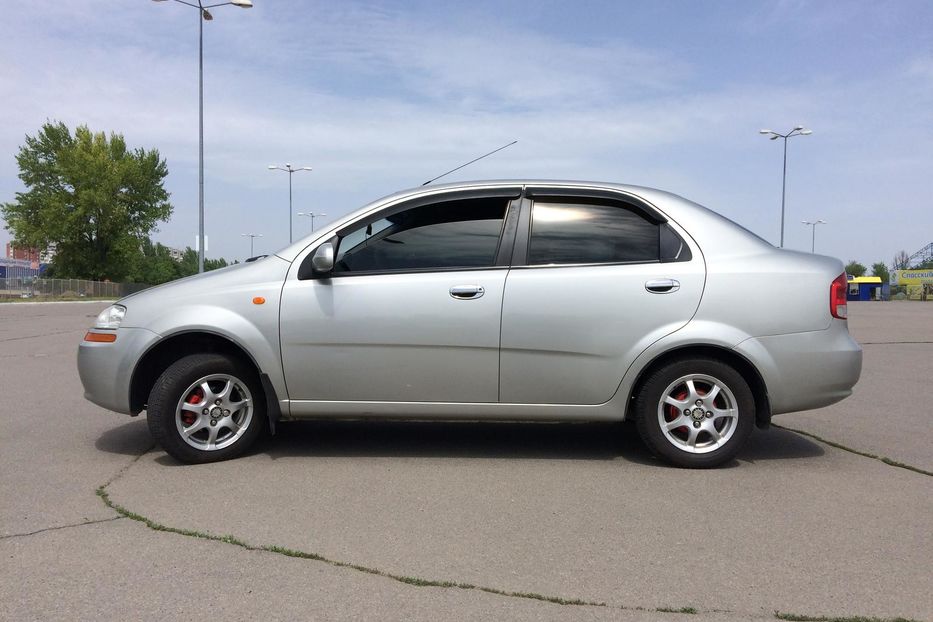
top-left (0, 302), bottom-right (933, 620)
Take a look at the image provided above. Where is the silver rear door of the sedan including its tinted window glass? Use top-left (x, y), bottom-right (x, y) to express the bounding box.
top-left (499, 188), bottom-right (705, 404)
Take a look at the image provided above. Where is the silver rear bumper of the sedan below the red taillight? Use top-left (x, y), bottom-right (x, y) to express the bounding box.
top-left (735, 320), bottom-right (862, 415)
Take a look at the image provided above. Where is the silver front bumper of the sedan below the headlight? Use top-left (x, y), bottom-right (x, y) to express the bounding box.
top-left (78, 328), bottom-right (159, 415)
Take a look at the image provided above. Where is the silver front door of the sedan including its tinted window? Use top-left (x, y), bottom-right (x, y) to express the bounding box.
top-left (280, 191), bottom-right (517, 403)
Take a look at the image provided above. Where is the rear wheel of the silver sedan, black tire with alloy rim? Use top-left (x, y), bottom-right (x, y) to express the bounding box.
top-left (633, 358), bottom-right (755, 469)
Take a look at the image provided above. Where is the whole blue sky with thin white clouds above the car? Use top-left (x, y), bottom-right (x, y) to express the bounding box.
top-left (0, 0), bottom-right (933, 265)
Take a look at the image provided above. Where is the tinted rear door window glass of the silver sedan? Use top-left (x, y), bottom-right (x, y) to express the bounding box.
top-left (528, 201), bottom-right (660, 265)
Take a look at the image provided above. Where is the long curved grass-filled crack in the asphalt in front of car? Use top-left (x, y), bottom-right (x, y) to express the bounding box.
top-left (97, 486), bottom-right (608, 609)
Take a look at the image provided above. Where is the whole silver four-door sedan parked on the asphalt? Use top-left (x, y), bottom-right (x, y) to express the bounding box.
top-left (78, 181), bottom-right (862, 467)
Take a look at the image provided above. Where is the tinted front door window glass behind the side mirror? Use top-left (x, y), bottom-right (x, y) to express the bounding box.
top-left (334, 198), bottom-right (508, 273)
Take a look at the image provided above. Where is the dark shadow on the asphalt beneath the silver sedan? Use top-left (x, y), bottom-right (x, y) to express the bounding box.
top-left (95, 417), bottom-right (825, 468)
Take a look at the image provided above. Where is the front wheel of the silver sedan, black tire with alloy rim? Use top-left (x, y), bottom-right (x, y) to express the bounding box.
top-left (146, 354), bottom-right (266, 464)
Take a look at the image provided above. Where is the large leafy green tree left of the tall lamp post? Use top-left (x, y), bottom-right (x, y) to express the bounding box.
top-left (0, 122), bottom-right (172, 281)
